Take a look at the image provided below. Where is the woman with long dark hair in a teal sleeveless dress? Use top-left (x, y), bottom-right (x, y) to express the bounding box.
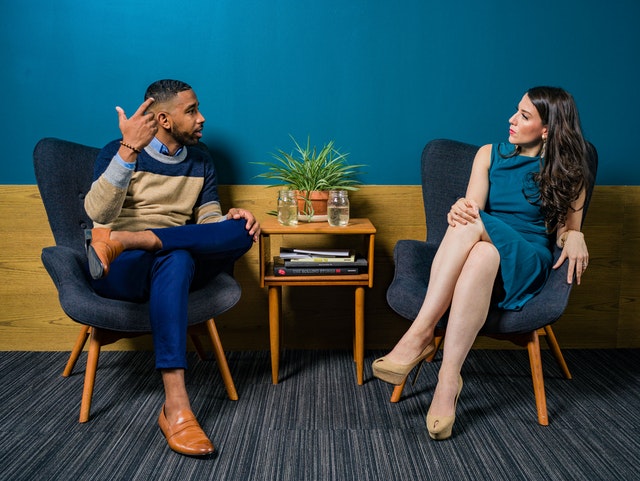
top-left (372, 87), bottom-right (589, 439)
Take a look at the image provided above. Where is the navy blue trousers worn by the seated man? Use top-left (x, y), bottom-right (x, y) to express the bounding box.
top-left (93, 219), bottom-right (253, 369)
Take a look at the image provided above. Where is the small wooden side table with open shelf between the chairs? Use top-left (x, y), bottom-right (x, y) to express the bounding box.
top-left (260, 217), bottom-right (376, 384)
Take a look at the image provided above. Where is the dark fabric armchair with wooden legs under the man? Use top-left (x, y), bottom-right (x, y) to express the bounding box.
top-left (33, 138), bottom-right (241, 422)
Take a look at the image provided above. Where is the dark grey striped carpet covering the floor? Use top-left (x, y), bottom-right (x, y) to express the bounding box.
top-left (0, 350), bottom-right (640, 481)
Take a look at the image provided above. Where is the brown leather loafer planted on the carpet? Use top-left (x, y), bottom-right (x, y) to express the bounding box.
top-left (158, 405), bottom-right (214, 456)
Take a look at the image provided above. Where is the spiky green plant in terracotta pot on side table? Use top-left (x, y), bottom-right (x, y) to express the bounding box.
top-left (254, 135), bottom-right (364, 221)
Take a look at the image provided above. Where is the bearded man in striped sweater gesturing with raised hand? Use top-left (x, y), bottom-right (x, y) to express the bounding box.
top-left (85, 80), bottom-right (260, 456)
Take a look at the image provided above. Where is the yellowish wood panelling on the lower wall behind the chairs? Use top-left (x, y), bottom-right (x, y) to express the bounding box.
top-left (0, 185), bottom-right (640, 351)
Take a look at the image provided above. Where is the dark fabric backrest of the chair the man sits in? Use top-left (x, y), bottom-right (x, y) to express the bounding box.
top-left (33, 138), bottom-right (100, 252)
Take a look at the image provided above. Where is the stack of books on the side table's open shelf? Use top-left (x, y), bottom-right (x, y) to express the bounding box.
top-left (273, 247), bottom-right (368, 276)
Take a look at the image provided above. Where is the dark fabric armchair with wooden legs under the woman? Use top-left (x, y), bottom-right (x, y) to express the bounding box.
top-left (387, 139), bottom-right (598, 425)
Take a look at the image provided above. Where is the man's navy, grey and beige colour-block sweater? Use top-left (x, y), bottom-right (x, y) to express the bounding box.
top-left (85, 140), bottom-right (225, 231)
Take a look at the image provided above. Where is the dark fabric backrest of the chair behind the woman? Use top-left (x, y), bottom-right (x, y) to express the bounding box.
top-left (422, 139), bottom-right (598, 245)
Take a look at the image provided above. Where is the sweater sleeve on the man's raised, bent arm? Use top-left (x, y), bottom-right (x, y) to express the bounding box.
top-left (84, 141), bottom-right (134, 224)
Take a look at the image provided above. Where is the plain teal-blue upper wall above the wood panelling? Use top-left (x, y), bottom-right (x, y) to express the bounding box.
top-left (0, 0), bottom-right (640, 184)
